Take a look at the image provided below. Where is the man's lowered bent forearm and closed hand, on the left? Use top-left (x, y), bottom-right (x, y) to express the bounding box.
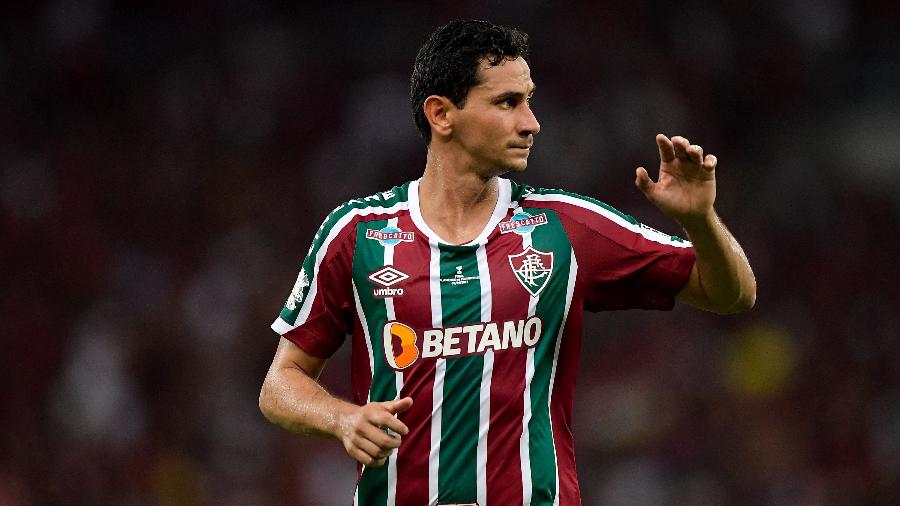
top-left (259, 337), bottom-right (412, 467)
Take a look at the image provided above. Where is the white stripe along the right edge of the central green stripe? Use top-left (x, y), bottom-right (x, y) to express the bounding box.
top-left (475, 245), bottom-right (494, 505)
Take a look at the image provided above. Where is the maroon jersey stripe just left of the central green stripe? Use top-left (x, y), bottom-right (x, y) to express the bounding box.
top-left (394, 212), bottom-right (435, 504)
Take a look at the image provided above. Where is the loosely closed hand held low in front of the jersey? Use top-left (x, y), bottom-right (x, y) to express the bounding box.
top-left (340, 397), bottom-right (413, 467)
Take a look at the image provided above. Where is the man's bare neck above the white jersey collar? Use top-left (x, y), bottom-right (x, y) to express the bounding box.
top-left (419, 151), bottom-right (500, 244)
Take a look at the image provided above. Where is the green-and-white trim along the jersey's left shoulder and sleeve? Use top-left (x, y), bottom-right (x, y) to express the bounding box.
top-left (272, 201), bottom-right (409, 335)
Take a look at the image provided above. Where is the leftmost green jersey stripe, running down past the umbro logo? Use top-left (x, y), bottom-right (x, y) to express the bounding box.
top-left (353, 221), bottom-right (397, 505)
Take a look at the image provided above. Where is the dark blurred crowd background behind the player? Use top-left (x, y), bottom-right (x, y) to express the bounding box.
top-left (0, 0), bottom-right (900, 505)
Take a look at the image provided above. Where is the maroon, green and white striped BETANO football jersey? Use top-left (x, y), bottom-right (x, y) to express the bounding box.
top-left (272, 178), bottom-right (694, 506)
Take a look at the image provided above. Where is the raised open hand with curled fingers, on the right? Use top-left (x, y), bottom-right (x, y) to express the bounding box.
top-left (634, 134), bottom-right (717, 225)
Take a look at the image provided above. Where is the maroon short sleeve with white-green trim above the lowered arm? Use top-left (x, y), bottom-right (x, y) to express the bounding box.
top-left (272, 213), bottom-right (354, 358)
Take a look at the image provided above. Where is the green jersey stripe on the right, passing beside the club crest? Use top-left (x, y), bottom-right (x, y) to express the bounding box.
top-left (526, 209), bottom-right (572, 504)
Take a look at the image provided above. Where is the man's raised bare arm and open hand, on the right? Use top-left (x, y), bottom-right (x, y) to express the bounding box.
top-left (635, 134), bottom-right (756, 314)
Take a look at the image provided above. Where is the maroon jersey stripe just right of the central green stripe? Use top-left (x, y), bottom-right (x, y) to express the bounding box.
top-left (487, 229), bottom-right (531, 504)
